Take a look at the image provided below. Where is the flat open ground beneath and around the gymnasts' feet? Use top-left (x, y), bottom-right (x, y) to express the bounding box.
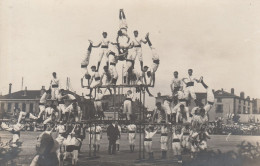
top-left (0, 131), bottom-right (260, 166)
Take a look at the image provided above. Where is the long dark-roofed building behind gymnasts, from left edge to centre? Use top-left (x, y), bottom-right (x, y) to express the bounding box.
top-left (0, 84), bottom-right (146, 120)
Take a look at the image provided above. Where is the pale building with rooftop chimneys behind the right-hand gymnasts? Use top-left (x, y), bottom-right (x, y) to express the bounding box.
top-left (155, 88), bottom-right (260, 122)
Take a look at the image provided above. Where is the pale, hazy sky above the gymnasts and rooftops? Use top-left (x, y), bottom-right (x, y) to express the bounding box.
top-left (0, 0), bottom-right (260, 108)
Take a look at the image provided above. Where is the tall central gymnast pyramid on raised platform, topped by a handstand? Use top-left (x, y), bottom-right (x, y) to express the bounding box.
top-left (81, 9), bottom-right (160, 96)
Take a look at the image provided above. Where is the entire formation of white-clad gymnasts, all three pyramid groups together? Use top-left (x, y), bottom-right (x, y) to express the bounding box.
top-left (1, 9), bottom-right (214, 165)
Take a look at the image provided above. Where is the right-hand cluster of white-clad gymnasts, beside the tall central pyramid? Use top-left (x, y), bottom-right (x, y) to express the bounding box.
top-left (144, 69), bottom-right (214, 162)
